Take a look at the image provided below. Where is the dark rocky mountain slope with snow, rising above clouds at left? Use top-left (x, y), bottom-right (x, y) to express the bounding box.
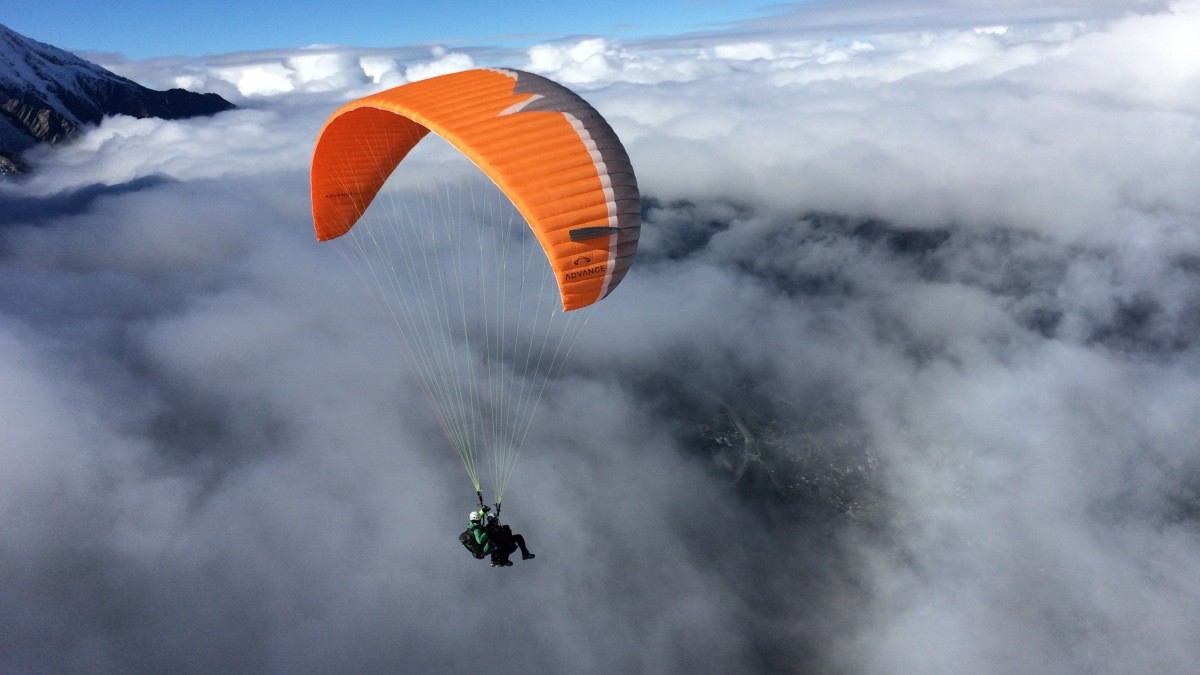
top-left (0, 24), bottom-right (235, 173)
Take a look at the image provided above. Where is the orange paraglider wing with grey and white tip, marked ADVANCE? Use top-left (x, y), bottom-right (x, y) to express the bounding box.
top-left (312, 68), bottom-right (641, 310)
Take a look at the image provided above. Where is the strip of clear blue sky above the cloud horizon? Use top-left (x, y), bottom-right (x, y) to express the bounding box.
top-left (0, 0), bottom-right (770, 59)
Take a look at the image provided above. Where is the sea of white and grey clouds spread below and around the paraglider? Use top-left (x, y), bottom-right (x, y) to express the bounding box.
top-left (0, 1), bottom-right (1200, 673)
